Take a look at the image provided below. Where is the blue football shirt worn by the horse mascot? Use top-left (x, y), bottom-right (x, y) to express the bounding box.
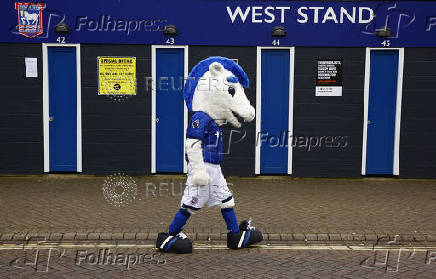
top-left (186, 111), bottom-right (223, 164)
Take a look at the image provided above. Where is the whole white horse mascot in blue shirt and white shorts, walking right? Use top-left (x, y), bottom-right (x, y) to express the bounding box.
top-left (156, 56), bottom-right (263, 253)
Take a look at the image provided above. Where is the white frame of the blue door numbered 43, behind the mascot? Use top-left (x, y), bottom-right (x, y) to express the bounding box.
top-left (151, 45), bottom-right (189, 173)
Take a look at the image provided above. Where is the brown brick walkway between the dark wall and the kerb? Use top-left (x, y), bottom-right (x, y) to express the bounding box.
top-left (0, 175), bottom-right (436, 242)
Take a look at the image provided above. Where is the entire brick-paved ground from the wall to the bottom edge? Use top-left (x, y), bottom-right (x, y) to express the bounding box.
top-left (0, 175), bottom-right (436, 279)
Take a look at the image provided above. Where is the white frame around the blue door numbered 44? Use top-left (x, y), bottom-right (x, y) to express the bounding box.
top-left (255, 46), bottom-right (295, 174)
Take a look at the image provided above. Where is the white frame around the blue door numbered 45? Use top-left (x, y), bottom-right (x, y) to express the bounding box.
top-left (361, 47), bottom-right (404, 175)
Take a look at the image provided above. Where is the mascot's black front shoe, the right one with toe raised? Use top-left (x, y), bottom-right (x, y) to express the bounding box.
top-left (227, 219), bottom-right (263, 249)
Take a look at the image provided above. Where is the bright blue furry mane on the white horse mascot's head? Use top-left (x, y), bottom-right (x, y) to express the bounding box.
top-left (183, 56), bottom-right (249, 111)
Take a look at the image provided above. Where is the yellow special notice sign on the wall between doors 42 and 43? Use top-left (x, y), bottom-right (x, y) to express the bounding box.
top-left (97, 56), bottom-right (136, 95)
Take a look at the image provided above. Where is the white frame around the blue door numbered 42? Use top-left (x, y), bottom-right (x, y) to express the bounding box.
top-left (42, 43), bottom-right (82, 172)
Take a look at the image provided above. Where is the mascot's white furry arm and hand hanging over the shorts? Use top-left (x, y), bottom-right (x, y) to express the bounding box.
top-left (186, 138), bottom-right (209, 186)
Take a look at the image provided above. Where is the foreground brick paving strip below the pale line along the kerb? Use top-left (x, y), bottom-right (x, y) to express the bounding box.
top-left (0, 248), bottom-right (436, 279)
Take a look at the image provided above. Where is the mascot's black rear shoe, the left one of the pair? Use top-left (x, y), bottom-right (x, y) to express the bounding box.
top-left (156, 232), bottom-right (192, 254)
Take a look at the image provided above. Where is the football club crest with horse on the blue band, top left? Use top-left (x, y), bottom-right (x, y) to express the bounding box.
top-left (15, 2), bottom-right (45, 38)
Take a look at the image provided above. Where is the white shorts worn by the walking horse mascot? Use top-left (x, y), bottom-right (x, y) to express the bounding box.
top-left (180, 162), bottom-right (233, 209)
